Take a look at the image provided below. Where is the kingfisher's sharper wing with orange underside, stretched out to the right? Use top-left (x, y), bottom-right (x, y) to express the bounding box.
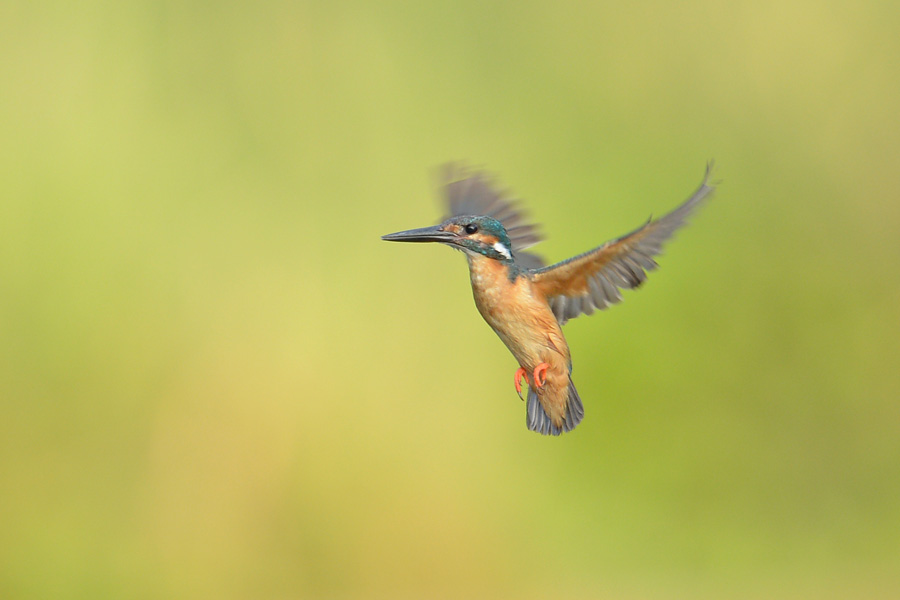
top-left (531, 163), bottom-right (715, 324)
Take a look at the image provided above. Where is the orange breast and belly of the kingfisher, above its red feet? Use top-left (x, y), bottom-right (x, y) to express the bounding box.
top-left (469, 257), bottom-right (568, 368)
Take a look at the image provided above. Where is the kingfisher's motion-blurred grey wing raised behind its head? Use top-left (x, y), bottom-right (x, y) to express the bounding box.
top-left (440, 163), bottom-right (544, 269)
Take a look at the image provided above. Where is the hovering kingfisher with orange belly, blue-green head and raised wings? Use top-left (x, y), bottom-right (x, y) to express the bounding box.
top-left (381, 162), bottom-right (715, 435)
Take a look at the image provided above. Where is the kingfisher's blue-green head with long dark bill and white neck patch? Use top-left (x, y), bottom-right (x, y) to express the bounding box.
top-left (381, 215), bottom-right (513, 261)
